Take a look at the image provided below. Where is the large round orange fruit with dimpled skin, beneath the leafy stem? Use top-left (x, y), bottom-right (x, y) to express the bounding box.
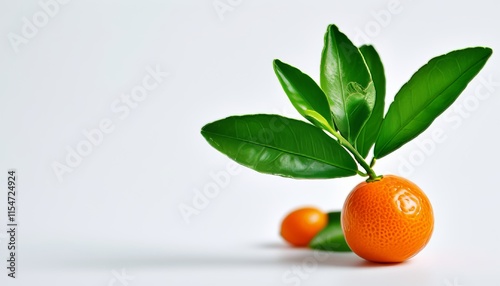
top-left (341, 175), bottom-right (434, 263)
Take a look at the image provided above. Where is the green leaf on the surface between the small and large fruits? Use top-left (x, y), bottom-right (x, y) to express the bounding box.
top-left (309, 212), bottom-right (351, 252)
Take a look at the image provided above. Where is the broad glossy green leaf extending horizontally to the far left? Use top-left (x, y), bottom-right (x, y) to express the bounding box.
top-left (201, 114), bottom-right (357, 179)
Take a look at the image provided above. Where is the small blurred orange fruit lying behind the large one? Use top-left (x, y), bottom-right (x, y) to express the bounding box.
top-left (281, 207), bottom-right (328, 246)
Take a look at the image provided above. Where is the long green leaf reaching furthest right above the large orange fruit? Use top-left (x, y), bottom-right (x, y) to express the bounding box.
top-left (375, 47), bottom-right (492, 158)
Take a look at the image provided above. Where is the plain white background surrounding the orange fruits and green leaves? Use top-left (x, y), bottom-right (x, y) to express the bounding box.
top-left (0, 0), bottom-right (500, 286)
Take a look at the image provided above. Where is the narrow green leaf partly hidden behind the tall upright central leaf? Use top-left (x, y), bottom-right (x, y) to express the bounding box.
top-left (356, 46), bottom-right (385, 158)
